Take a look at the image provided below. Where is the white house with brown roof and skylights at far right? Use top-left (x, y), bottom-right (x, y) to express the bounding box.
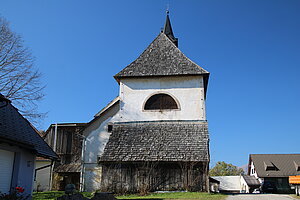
top-left (248, 154), bottom-right (300, 193)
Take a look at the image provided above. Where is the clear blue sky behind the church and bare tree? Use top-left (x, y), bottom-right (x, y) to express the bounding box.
top-left (0, 0), bottom-right (300, 166)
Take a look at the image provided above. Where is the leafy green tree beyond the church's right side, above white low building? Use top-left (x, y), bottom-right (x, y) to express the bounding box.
top-left (209, 161), bottom-right (245, 176)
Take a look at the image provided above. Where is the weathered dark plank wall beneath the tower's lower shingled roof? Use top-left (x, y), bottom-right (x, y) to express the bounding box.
top-left (101, 162), bottom-right (208, 193)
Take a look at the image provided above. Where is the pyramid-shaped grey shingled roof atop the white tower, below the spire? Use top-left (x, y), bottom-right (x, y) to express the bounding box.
top-left (114, 32), bottom-right (209, 80)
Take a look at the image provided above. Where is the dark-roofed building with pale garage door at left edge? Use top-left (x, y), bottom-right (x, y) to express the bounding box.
top-left (0, 94), bottom-right (57, 196)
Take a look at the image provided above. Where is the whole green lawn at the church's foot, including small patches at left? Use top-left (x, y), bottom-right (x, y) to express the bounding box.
top-left (33, 191), bottom-right (226, 200)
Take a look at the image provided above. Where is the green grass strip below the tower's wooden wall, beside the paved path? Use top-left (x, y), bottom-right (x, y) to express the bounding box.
top-left (117, 192), bottom-right (226, 200)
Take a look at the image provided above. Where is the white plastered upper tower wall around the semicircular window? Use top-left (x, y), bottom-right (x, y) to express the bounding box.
top-left (114, 76), bottom-right (206, 121)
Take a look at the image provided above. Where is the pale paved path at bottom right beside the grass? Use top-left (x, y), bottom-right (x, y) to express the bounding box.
top-left (226, 194), bottom-right (294, 200)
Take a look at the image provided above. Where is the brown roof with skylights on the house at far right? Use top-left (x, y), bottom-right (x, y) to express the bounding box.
top-left (248, 154), bottom-right (300, 177)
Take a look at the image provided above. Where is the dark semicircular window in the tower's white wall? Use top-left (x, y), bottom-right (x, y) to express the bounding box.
top-left (144, 93), bottom-right (178, 110)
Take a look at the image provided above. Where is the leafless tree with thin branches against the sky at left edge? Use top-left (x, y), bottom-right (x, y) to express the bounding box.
top-left (0, 17), bottom-right (45, 123)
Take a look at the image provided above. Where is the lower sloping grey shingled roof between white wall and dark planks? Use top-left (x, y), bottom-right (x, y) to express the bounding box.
top-left (100, 121), bottom-right (209, 162)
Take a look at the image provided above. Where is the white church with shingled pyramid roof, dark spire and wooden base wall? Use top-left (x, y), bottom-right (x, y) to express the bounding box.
top-left (82, 13), bottom-right (210, 192)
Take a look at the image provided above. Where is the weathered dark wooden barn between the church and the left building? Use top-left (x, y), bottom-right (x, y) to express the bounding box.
top-left (41, 123), bottom-right (86, 190)
